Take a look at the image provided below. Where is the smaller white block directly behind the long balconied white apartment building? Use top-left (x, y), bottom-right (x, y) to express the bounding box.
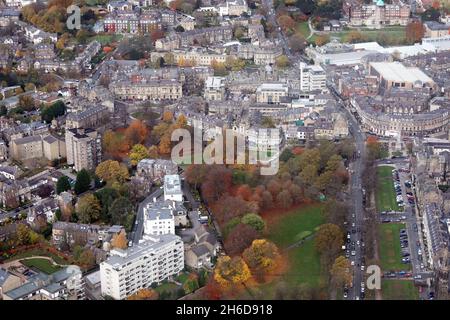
top-left (144, 201), bottom-right (175, 236)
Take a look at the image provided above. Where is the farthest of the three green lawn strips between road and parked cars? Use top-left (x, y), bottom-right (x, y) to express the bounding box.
top-left (376, 166), bottom-right (401, 212)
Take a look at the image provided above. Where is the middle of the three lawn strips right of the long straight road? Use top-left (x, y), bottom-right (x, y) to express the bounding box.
top-left (378, 223), bottom-right (411, 271)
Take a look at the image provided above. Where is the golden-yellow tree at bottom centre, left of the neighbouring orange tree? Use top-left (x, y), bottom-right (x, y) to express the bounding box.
top-left (214, 256), bottom-right (251, 288)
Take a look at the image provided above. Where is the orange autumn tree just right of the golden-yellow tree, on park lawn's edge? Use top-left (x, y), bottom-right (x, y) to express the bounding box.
top-left (242, 239), bottom-right (280, 273)
